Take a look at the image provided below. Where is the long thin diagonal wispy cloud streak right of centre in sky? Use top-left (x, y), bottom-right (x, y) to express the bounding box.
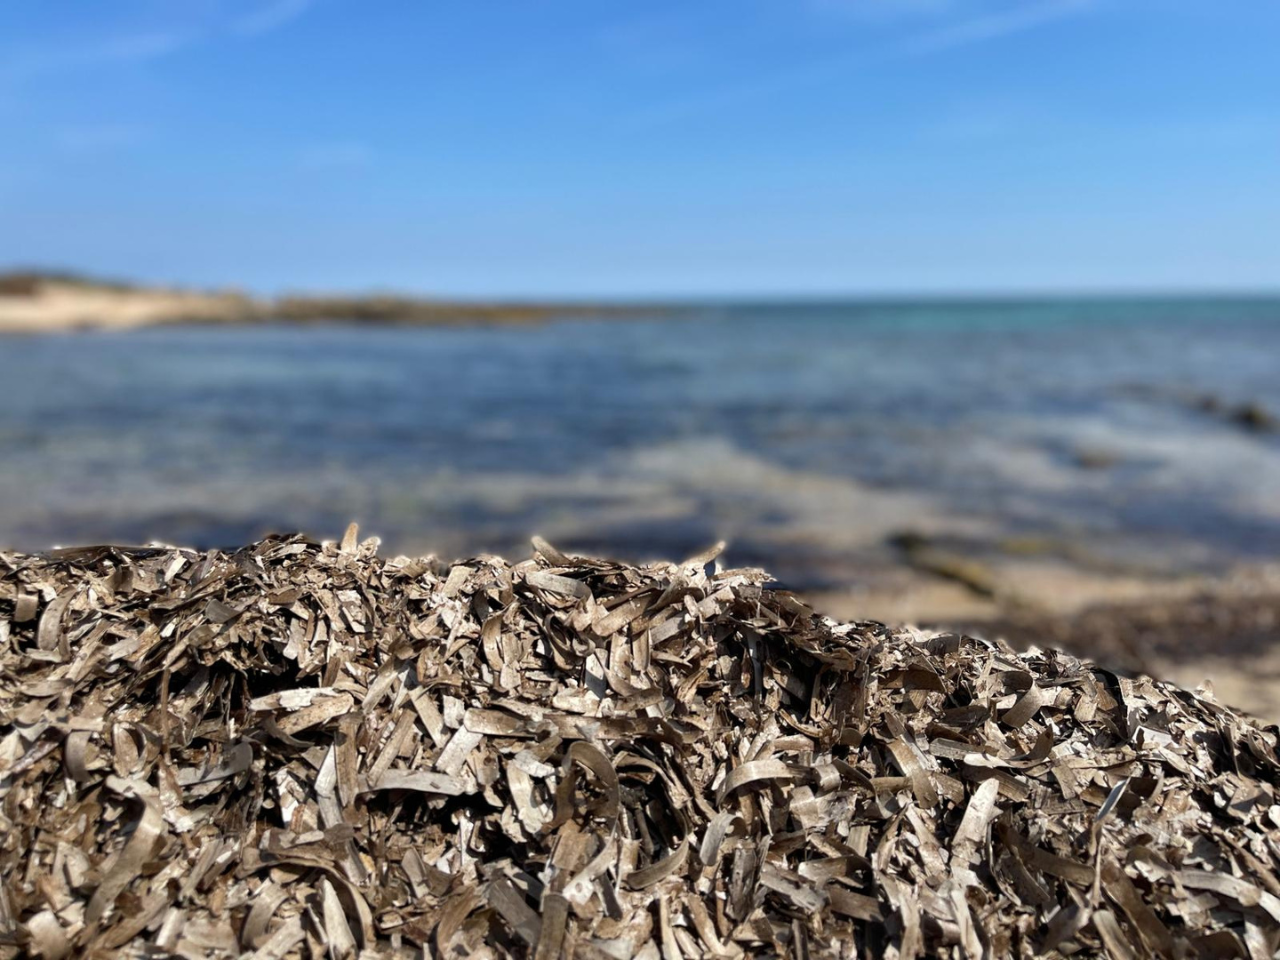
top-left (621, 0), bottom-right (1096, 131)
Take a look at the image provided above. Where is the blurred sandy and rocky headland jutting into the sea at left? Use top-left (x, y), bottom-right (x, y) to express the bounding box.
top-left (0, 270), bottom-right (662, 333)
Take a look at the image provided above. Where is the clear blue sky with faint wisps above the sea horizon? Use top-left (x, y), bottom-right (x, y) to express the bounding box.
top-left (0, 0), bottom-right (1280, 297)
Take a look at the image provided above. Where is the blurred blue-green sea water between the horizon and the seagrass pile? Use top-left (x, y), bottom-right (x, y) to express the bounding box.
top-left (0, 300), bottom-right (1280, 585)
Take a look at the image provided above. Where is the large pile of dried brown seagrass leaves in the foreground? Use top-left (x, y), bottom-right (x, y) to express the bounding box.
top-left (0, 531), bottom-right (1280, 960)
